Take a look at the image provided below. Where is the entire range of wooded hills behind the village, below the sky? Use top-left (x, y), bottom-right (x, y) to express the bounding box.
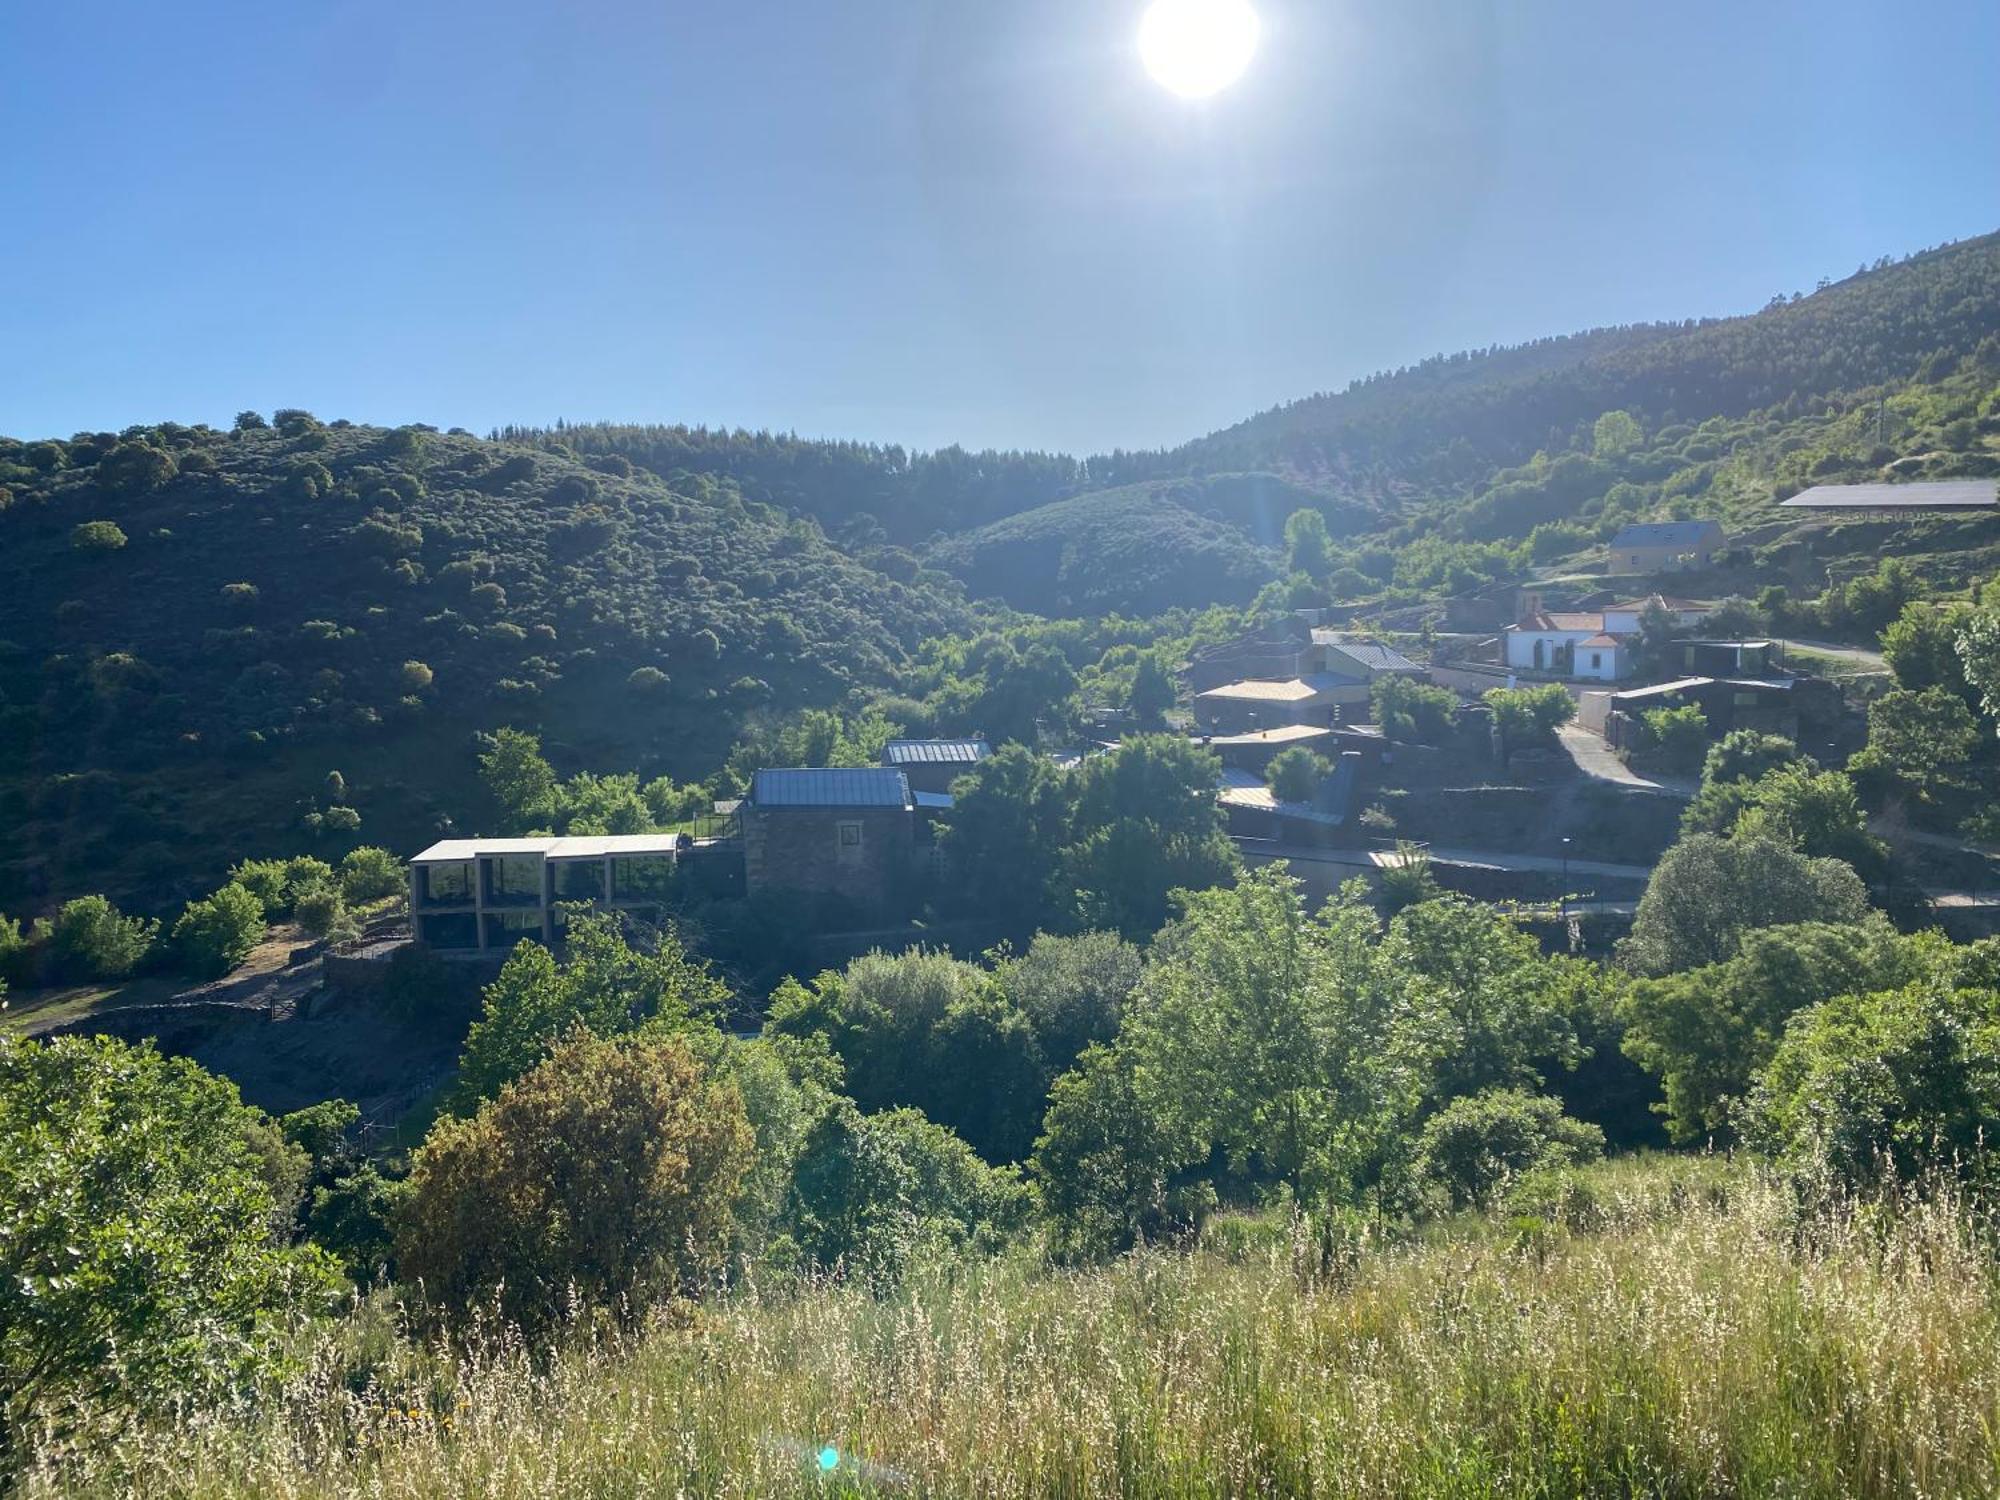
top-left (11, 236), bottom-right (2000, 906)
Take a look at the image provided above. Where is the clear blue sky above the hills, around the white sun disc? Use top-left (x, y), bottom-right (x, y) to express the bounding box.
top-left (0, 0), bottom-right (2000, 452)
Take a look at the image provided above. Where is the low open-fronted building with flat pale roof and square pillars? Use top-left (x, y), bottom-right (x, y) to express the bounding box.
top-left (410, 834), bottom-right (682, 952)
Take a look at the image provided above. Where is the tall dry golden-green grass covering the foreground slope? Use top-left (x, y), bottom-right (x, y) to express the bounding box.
top-left (22, 1164), bottom-right (2000, 1500)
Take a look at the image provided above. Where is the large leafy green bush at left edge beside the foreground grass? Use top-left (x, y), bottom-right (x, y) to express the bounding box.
top-left (0, 1036), bottom-right (334, 1464)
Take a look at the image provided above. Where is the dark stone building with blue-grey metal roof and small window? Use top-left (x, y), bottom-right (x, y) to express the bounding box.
top-left (736, 766), bottom-right (916, 926)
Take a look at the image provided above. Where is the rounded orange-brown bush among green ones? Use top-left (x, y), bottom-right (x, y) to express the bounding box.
top-left (396, 1030), bottom-right (750, 1328)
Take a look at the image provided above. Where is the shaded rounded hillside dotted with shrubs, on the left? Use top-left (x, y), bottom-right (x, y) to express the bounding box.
top-left (0, 424), bottom-right (966, 906)
